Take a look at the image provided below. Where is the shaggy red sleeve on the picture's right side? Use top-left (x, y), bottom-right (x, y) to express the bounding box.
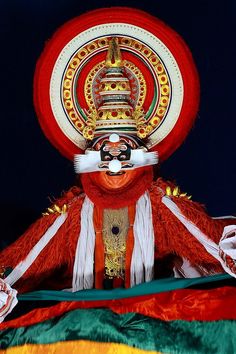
top-left (150, 179), bottom-right (233, 272)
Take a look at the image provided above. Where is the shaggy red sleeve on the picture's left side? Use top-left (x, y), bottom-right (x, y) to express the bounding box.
top-left (0, 185), bottom-right (83, 293)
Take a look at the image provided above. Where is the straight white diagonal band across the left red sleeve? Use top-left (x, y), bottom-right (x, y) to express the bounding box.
top-left (4, 213), bottom-right (67, 285)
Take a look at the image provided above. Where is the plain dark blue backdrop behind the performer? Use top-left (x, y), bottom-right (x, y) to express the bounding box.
top-left (0, 0), bottom-right (236, 247)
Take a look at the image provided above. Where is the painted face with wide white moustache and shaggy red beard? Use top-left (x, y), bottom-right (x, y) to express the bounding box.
top-left (78, 134), bottom-right (158, 195)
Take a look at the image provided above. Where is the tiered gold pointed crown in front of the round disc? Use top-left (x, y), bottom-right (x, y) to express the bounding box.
top-left (83, 38), bottom-right (150, 140)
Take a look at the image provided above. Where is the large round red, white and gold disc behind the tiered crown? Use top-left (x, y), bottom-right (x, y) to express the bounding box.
top-left (34, 7), bottom-right (199, 161)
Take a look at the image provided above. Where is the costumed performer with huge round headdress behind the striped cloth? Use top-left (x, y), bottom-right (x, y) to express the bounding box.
top-left (0, 8), bottom-right (236, 319)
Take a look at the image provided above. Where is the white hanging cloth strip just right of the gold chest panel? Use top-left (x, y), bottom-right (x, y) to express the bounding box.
top-left (130, 192), bottom-right (155, 286)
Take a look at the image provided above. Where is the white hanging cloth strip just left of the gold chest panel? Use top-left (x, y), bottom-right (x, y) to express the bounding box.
top-left (72, 197), bottom-right (95, 292)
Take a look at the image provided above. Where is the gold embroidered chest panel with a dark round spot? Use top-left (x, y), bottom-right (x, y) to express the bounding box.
top-left (103, 208), bottom-right (129, 279)
